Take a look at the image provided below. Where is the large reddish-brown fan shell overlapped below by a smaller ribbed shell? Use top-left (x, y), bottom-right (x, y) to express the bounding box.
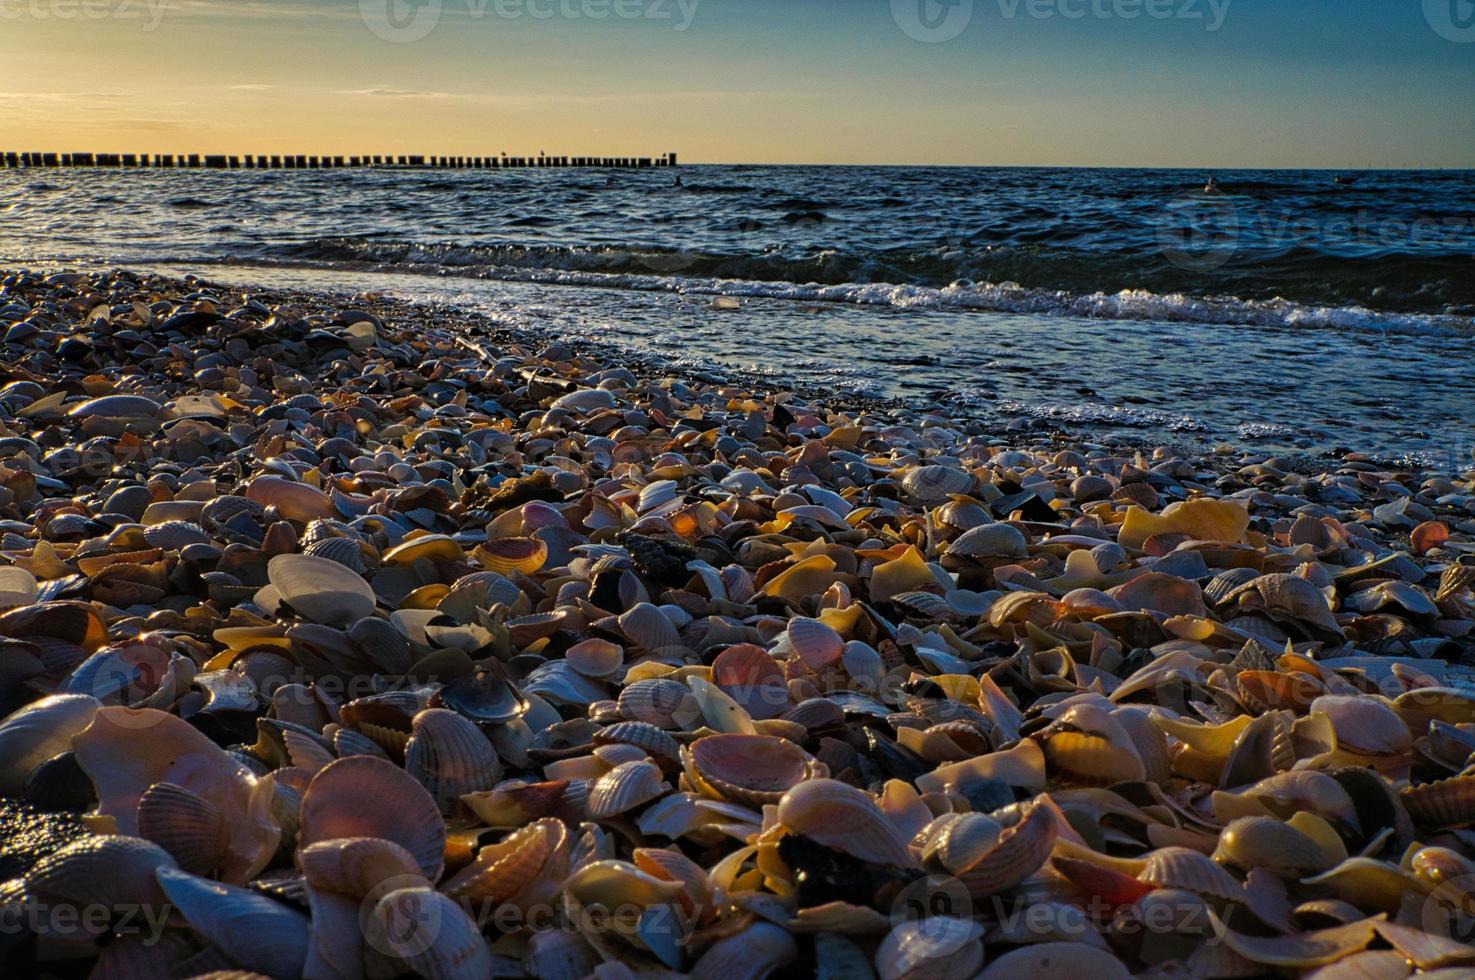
top-left (298, 756), bottom-right (445, 881)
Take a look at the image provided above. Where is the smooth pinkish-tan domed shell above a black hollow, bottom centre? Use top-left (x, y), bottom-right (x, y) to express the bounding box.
top-left (777, 779), bottom-right (914, 868)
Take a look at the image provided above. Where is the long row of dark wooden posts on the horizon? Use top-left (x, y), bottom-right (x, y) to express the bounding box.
top-left (0, 152), bottom-right (676, 170)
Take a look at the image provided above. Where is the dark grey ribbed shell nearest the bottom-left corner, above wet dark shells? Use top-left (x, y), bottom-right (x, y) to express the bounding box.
top-left (25, 835), bottom-right (176, 915)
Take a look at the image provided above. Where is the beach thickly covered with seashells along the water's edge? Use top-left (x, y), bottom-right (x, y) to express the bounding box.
top-left (0, 262), bottom-right (1475, 980)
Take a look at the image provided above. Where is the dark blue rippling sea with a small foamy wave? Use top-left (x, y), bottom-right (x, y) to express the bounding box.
top-left (0, 165), bottom-right (1475, 469)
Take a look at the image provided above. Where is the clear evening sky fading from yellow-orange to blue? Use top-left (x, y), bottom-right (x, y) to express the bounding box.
top-left (0, 0), bottom-right (1475, 168)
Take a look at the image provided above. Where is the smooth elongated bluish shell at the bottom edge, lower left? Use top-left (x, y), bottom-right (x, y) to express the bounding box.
top-left (156, 868), bottom-right (310, 977)
